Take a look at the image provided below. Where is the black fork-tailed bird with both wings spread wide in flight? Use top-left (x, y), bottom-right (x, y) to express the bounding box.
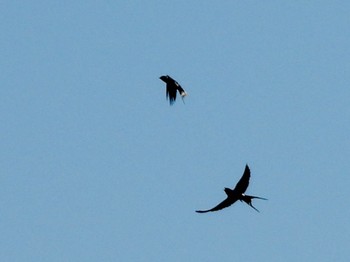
top-left (196, 165), bottom-right (267, 213)
